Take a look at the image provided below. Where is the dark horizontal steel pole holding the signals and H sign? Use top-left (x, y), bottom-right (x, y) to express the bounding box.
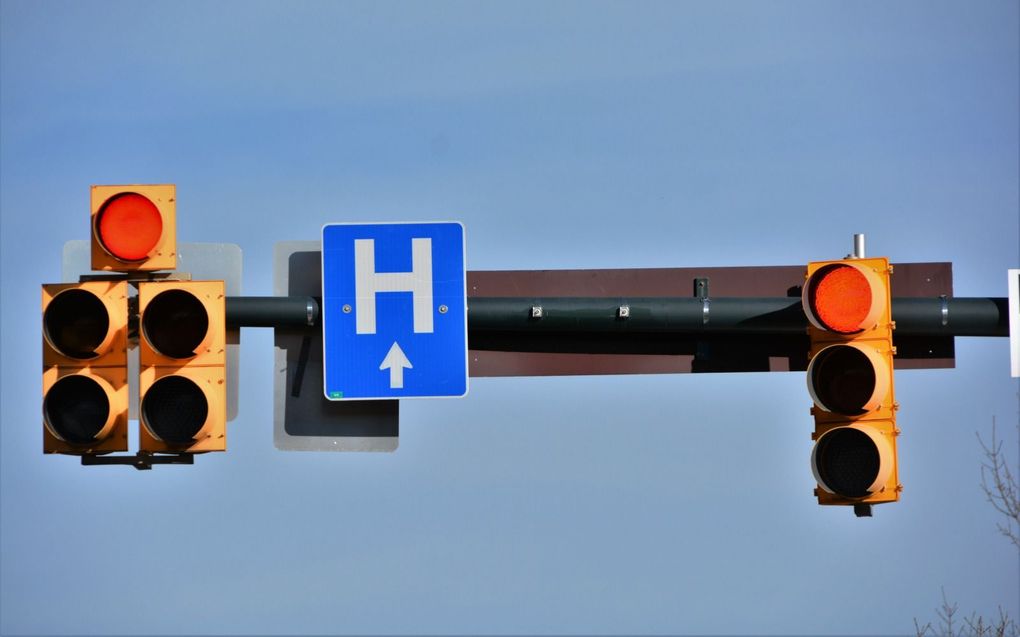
top-left (226, 297), bottom-right (1009, 336)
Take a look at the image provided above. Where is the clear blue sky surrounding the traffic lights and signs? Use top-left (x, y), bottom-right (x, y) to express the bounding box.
top-left (0, 0), bottom-right (1020, 634)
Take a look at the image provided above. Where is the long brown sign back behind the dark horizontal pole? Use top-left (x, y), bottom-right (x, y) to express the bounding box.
top-left (467, 263), bottom-right (956, 376)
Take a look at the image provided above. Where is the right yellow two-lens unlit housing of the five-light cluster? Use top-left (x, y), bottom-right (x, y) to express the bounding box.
top-left (138, 281), bottom-right (226, 454)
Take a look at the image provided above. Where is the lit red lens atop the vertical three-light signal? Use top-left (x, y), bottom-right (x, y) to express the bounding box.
top-left (808, 265), bottom-right (873, 334)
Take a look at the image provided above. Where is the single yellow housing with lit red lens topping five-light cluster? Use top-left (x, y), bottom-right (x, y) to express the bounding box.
top-left (92, 183), bottom-right (176, 272)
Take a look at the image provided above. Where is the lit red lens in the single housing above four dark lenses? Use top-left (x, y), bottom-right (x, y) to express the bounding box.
top-left (96, 193), bottom-right (163, 261)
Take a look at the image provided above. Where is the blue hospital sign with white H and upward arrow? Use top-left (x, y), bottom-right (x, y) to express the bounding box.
top-left (322, 222), bottom-right (467, 401)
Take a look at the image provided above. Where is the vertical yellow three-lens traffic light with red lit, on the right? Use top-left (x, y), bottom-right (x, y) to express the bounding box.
top-left (802, 258), bottom-right (903, 509)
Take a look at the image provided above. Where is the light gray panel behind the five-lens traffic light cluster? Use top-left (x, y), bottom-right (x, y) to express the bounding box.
top-left (61, 240), bottom-right (242, 420)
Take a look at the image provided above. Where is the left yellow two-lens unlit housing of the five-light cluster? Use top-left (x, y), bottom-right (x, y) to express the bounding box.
top-left (43, 281), bottom-right (128, 456)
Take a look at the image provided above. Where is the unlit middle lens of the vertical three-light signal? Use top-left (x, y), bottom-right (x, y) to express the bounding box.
top-left (811, 346), bottom-right (875, 416)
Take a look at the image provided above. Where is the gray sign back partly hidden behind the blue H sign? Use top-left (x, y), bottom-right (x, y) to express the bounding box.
top-left (272, 242), bottom-right (400, 452)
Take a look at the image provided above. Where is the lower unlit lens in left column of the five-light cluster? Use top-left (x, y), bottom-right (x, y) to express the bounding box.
top-left (43, 375), bottom-right (110, 444)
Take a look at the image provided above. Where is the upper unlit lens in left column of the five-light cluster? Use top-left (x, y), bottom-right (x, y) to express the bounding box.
top-left (43, 288), bottom-right (110, 359)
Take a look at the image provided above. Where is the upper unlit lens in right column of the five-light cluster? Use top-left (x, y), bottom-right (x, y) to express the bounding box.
top-left (142, 289), bottom-right (209, 359)
